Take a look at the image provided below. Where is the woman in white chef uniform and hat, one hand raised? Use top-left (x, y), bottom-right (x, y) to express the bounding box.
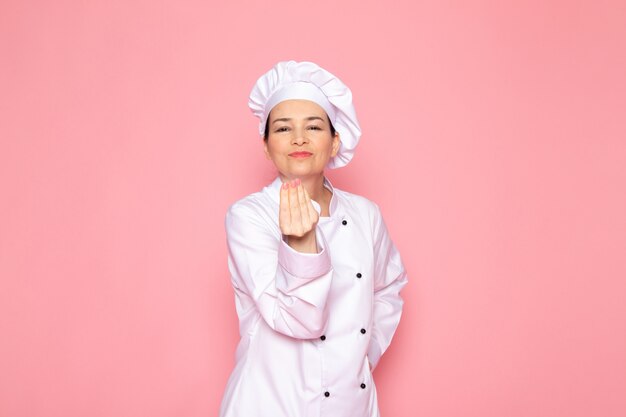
top-left (220, 61), bottom-right (407, 417)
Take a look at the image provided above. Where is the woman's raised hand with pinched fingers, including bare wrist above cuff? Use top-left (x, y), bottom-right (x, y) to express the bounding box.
top-left (278, 178), bottom-right (319, 253)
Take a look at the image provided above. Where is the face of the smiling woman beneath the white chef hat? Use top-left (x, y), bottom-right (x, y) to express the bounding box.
top-left (263, 100), bottom-right (339, 179)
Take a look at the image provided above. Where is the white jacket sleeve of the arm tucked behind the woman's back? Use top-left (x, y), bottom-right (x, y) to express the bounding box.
top-left (367, 204), bottom-right (408, 370)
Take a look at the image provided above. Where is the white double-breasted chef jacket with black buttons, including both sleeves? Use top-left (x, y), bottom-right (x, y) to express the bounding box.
top-left (219, 177), bottom-right (407, 417)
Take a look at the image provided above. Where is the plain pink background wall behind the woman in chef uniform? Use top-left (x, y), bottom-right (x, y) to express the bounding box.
top-left (0, 0), bottom-right (626, 417)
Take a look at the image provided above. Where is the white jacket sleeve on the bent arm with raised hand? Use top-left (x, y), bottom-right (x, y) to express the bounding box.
top-left (225, 200), bottom-right (333, 339)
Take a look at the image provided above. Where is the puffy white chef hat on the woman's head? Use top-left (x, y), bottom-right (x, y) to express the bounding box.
top-left (248, 61), bottom-right (361, 168)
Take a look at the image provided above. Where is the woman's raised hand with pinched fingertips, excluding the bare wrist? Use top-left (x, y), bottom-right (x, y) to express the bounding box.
top-left (278, 178), bottom-right (319, 237)
